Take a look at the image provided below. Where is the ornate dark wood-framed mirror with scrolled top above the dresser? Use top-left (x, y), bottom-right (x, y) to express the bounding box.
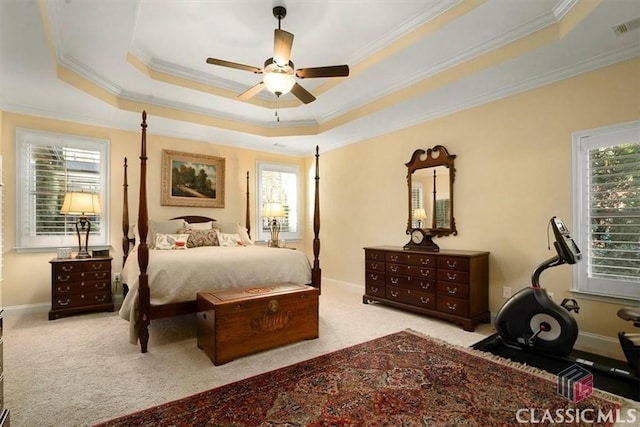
top-left (406, 145), bottom-right (458, 250)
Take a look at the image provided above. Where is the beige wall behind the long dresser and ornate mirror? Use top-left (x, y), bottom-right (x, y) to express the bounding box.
top-left (321, 59), bottom-right (640, 354)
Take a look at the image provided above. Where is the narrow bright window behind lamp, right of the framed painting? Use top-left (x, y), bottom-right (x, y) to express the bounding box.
top-left (255, 162), bottom-right (302, 241)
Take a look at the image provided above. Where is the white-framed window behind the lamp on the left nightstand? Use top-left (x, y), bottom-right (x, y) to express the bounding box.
top-left (16, 129), bottom-right (109, 251)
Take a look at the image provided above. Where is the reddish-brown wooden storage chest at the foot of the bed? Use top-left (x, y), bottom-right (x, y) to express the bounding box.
top-left (196, 284), bottom-right (319, 365)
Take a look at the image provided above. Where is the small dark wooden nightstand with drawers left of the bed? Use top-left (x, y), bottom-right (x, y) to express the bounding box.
top-left (49, 258), bottom-right (113, 320)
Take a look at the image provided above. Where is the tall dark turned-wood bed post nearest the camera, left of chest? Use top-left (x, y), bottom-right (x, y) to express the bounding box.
top-left (137, 111), bottom-right (151, 353)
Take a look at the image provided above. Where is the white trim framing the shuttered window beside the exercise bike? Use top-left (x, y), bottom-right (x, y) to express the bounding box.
top-left (572, 120), bottom-right (640, 301)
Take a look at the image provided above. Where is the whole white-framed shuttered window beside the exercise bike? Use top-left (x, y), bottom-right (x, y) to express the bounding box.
top-left (573, 122), bottom-right (640, 300)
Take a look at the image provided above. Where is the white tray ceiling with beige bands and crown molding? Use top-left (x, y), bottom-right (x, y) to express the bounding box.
top-left (0, 0), bottom-right (640, 155)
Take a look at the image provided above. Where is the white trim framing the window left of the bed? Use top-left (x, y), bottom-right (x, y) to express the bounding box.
top-left (15, 128), bottom-right (110, 252)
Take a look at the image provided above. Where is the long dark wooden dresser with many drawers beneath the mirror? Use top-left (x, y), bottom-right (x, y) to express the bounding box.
top-left (362, 246), bottom-right (490, 331)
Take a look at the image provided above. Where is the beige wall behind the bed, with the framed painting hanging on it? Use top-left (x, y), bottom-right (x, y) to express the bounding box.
top-left (0, 112), bottom-right (307, 306)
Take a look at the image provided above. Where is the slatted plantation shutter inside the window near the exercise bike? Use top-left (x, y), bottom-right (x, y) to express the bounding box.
top-left (588, 142), bottom-right (640, 284)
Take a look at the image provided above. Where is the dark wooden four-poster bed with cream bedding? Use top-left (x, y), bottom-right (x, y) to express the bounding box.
top-left (120, 112), bottom-right (321, 353)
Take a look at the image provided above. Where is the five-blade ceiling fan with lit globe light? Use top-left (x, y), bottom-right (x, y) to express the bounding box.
top-left (207, 6), bottom-right (349, 104)
